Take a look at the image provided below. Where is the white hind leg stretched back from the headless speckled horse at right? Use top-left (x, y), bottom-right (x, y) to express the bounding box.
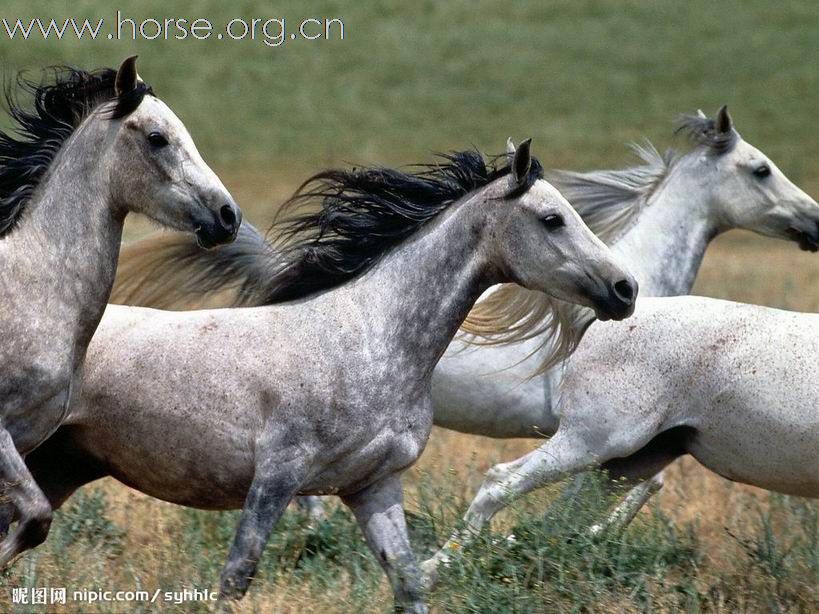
top-left (421, 432), bottom-right (595, 588)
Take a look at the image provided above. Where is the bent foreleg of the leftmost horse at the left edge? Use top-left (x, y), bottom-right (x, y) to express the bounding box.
top-left (0, 428), bottom-right (52, 569)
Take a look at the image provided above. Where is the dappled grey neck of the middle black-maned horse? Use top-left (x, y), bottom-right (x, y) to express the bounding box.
top-left (344, 196), bottom-right (499, 376)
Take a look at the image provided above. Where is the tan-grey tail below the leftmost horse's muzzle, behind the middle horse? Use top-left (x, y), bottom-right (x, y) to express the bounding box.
top-left (110, 222), bottom-right (281, 310)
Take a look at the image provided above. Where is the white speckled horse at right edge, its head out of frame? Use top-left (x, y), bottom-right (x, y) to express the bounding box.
top-left (423, 296), bottom-right (819, 582)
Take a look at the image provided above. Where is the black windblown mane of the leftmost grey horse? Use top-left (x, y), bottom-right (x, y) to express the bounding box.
top-left (0, 66), bottom-right (153, 238)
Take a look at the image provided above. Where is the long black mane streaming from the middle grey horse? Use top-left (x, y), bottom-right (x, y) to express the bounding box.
top-left (257, 150), bottom-right (543, 304)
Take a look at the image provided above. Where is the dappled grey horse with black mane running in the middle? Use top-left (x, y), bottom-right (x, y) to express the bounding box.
top-left (6, 142), bottom-right (637, 611)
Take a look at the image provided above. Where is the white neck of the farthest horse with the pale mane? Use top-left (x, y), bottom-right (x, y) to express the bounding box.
top-left (612, 159), bottom-right (719, 296)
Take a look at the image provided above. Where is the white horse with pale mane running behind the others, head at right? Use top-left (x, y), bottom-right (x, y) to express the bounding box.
top-left (432, 107), bottom-right (819, 438)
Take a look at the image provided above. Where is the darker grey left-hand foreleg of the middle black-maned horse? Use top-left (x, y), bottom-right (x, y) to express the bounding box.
top-left (219, 449), bottom-right (304, 600)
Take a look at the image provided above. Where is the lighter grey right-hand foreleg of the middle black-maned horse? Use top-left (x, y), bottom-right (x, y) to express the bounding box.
top-left (343, 474), bottom-right (427, 612)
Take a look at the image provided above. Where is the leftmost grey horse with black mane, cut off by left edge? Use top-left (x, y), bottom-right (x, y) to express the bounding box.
top-left (0, 58), bottom-right (240, 567)
